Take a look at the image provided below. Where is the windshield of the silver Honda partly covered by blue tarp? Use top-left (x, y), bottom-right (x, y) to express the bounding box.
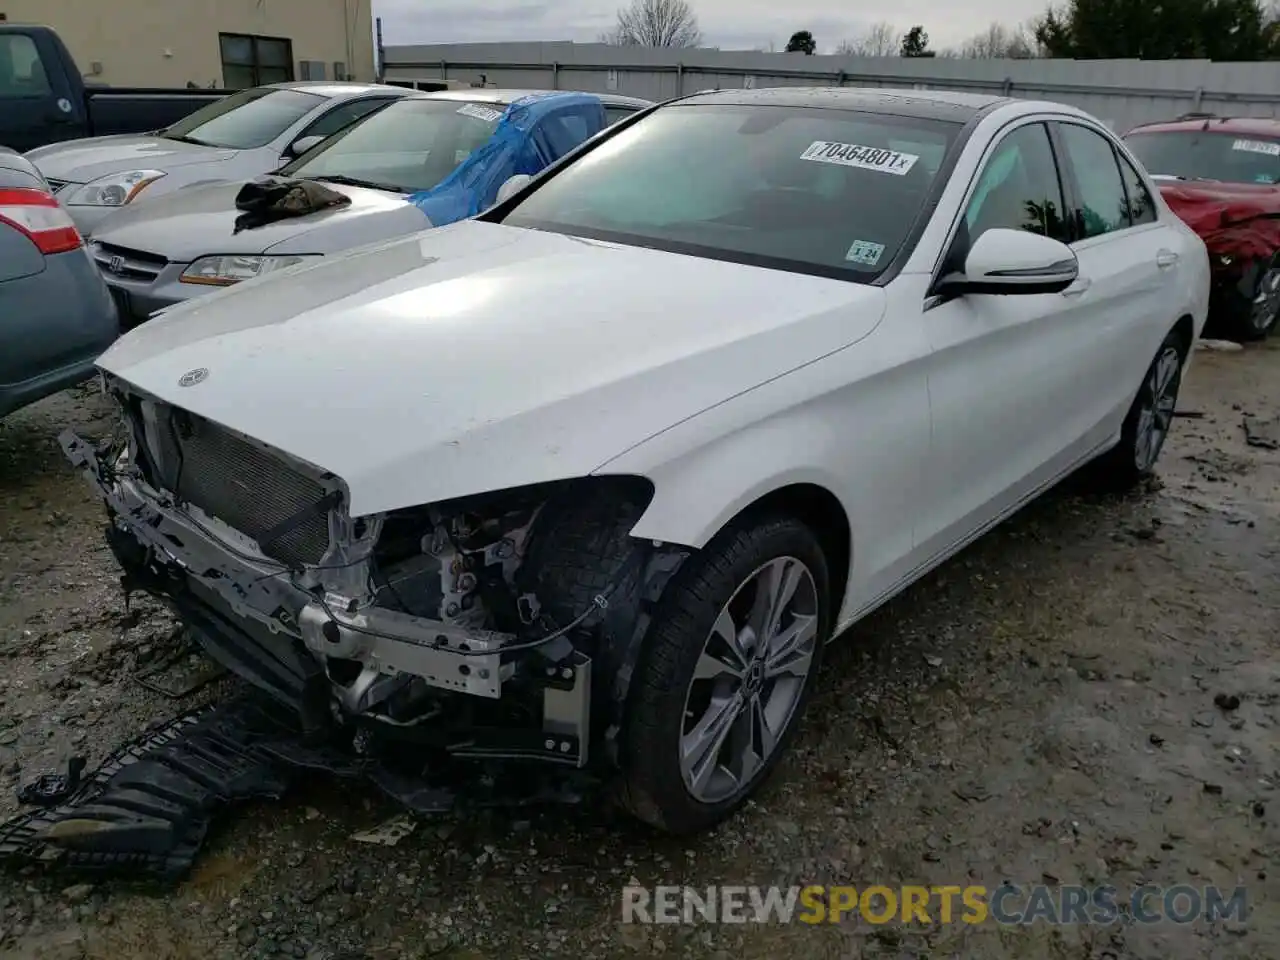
top-left (280, 100), bottom-right (506, 193)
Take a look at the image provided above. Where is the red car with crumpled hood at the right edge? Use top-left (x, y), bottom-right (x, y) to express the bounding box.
top-left (1124, 114), bottom-right (1280, 340)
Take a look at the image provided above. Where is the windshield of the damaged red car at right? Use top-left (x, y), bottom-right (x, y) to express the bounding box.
top-left (1124, 131), bottom-right (1280, 183)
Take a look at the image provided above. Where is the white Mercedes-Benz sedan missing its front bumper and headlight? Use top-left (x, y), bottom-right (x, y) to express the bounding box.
top-left (63, 88), bottom-right (1210, 832)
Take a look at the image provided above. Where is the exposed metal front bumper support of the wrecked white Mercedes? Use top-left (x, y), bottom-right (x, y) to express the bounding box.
top-left (59, 431), bottom-right (591, 767)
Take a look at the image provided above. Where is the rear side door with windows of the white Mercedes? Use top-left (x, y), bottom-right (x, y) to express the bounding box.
top-left (1052, 120), bottom-right (1181, 432)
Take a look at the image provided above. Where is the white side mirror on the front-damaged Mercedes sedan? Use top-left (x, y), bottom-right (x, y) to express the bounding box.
top-left (933, 228), bottom-right (1080, 296)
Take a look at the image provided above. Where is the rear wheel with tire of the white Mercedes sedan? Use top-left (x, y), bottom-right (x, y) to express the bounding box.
top-left (1093, 330), bottom-right (1190, 492)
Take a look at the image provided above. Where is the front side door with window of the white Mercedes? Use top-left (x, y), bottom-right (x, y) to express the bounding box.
top-left (916, 118), bottom-right (1106, 557)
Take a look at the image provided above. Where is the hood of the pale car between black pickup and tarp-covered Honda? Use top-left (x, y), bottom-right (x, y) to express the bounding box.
top-left (27, 134), bottom-right (237, 183)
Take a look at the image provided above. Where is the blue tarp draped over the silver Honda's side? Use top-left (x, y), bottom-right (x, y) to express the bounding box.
top-left (408, 93), bottom-right (608, 227)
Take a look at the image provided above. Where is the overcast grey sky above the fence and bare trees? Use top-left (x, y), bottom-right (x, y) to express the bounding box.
top-left (374, 0), bottom-right (1043, 52)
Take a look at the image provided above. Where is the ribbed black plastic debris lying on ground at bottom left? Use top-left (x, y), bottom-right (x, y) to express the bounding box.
top-left (0, 699), bottom-right (292, 879)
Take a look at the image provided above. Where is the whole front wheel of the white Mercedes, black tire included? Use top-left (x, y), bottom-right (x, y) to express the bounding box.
top-left (621, 517), bottom-right (832, 835)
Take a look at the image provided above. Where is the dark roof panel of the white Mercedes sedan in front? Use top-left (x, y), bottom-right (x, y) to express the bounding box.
top-left (675, 87), bottom-right (1014, 122)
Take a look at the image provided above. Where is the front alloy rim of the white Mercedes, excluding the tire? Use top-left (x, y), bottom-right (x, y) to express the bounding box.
top-left (680, 557), bottom-right (818, 804)
